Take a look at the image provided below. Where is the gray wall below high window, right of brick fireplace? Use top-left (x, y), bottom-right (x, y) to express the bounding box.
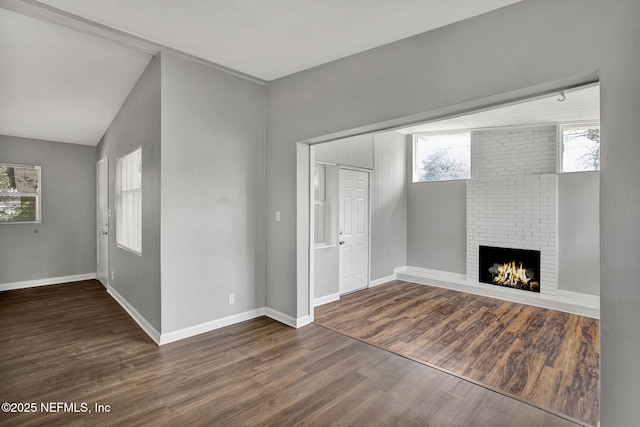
top-left (558, 172), bottom-right (600, 295)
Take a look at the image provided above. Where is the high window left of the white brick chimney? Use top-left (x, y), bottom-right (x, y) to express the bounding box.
top-left (413, 131), bottom-right (471, 182)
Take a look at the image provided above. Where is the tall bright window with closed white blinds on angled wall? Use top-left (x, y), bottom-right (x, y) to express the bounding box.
top-left (116, 148), bottom-right (142, 254)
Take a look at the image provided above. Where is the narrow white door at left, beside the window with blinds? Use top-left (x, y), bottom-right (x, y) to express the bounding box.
top-left (96, 157), bottom-right (109, 288)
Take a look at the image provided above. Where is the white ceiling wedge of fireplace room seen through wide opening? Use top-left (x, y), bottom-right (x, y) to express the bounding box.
top-left (401, 84), bottom-right (600, 133)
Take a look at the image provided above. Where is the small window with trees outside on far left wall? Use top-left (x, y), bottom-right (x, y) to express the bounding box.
top-left (0, 163), bottom-right (40, 223)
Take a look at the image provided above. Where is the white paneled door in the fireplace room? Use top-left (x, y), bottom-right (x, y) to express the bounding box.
top-left (338, 169), bottom-right (369, 294)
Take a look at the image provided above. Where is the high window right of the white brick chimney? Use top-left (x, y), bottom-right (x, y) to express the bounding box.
top-left (560, 123), bottom-right (600, 172)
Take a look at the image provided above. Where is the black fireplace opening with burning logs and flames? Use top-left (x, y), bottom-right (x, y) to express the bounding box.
top-left (479, 246), bottom-right (540, 292)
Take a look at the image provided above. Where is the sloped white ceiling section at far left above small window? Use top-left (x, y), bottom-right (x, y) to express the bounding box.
top-left (0, 8), bottom-right (151, 145)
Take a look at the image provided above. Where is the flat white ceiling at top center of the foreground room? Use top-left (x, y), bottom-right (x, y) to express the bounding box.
top-left (40, 0), bottom-right (520, 81)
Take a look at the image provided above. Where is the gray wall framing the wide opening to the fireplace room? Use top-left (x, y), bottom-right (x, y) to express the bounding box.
top-left (266, 0), bottom-right (640, 427)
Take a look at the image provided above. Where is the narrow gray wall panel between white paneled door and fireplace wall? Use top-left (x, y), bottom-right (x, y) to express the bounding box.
top-left (369, 132), bottom-right (407, 280)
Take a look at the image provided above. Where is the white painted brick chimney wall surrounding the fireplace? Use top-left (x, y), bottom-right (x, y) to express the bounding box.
top-left (467, 126), bottom-right (558, 294)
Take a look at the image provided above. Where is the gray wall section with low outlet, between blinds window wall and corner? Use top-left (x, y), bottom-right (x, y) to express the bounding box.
top-left (161, 54), bottom-right (268, 333)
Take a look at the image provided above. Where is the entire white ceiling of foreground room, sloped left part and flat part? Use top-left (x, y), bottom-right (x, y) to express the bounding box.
top-left (0, 0), bottom-right (536, 145)
